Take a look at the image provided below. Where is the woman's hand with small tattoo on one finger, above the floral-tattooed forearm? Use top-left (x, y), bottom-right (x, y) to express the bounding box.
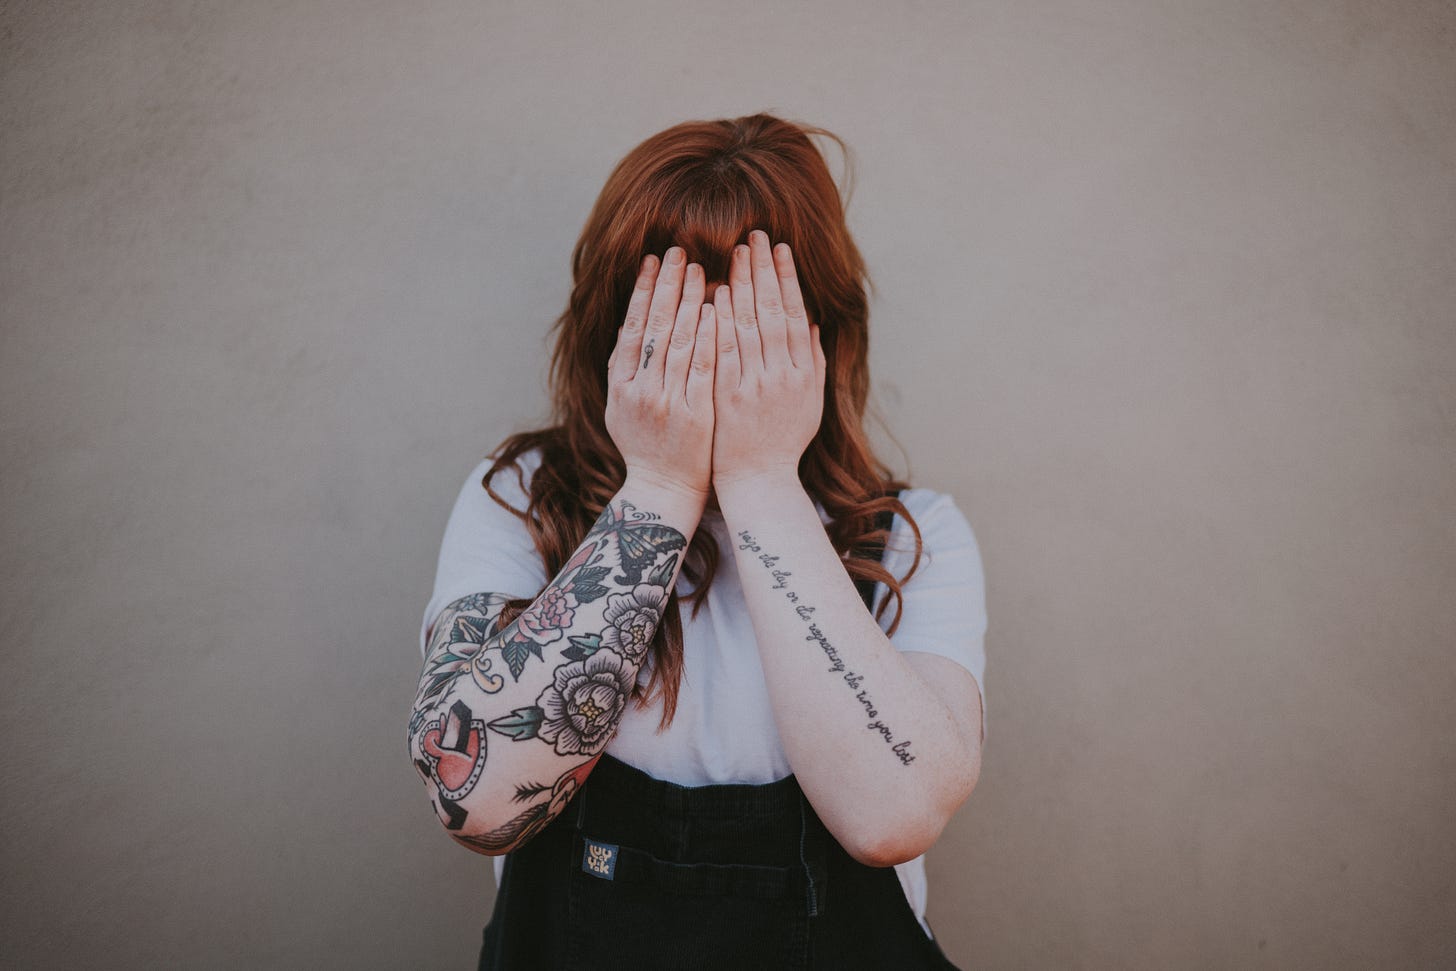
top-left (606, 246), bottom-right (718, 508)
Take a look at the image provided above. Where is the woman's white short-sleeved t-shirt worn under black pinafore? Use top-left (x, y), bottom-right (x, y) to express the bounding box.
top-left (419, 450), bottom-right (986, 935)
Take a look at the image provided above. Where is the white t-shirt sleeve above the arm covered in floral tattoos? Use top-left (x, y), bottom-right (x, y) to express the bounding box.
top-left (419, 451), bottom-right (547, 658)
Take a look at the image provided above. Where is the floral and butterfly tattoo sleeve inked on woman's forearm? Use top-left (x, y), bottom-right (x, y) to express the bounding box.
top-left (409, 501), bottom-right (687, 852)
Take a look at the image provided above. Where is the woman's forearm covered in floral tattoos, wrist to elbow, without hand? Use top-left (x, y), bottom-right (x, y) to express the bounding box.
top-left (409, 477), bottom-right (702, 856)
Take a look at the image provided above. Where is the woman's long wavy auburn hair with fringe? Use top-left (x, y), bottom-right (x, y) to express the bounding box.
top-left (480, 114), bottom-right (922, 732)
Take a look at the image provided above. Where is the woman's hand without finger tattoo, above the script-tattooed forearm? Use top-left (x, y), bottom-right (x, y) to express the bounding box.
top-left (713, 230), bottom-right (824, 495)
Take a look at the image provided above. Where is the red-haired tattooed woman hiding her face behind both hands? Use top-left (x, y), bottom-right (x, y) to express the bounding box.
top-left (409, 114), bottom-right (984, 968)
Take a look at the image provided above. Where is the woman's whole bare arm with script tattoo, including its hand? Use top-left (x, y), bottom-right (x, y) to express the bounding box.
top-left (701, 230), bottom-right (980, 866)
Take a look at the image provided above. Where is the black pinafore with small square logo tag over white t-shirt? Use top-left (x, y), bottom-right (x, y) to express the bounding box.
top-left (479, 500), bottom-right (955, 971)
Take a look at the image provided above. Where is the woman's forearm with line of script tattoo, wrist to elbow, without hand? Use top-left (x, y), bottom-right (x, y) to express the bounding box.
top-left (718, 475), bottom-right (976, 862)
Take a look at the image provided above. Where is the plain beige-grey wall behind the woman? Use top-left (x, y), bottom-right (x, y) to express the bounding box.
top-left (0, 0), bottom-right (1456, 968)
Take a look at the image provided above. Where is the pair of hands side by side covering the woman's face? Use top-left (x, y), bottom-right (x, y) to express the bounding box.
top-left (606, 230), bottom-right (826, 498)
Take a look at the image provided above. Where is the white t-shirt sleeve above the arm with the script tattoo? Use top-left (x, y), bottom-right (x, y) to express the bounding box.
top-left (875, 489), bottom-right (986, 740)
